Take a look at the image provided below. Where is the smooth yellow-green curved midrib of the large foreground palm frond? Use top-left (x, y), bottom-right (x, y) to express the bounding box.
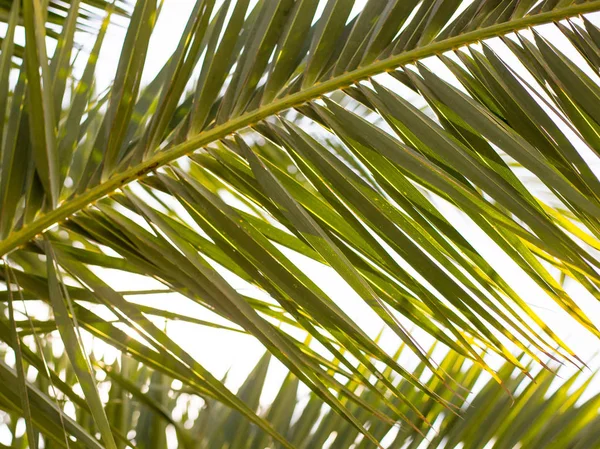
top-left (0, 0), bottom-right (600, 256)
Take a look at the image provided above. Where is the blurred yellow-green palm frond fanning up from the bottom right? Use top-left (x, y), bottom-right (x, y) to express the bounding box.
top-left (180, 346), bottom-right (600, 449)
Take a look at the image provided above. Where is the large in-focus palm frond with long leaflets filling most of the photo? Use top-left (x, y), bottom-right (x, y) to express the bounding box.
top-left (0, 0), bottom-right (600, 449)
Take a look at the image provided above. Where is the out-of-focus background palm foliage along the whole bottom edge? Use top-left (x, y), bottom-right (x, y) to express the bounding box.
top-left (0, 339), bottom-right (600, 449)
